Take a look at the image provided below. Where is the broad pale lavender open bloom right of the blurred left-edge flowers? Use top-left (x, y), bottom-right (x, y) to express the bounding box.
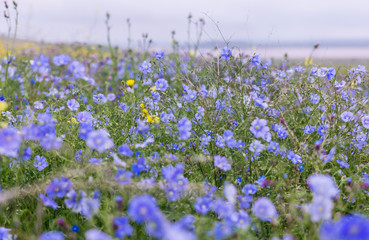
top-left (86, 129), bottom-right (114, 153)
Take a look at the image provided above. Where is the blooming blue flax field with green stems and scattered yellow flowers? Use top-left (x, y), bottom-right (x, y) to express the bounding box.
top-left (0, 37), bottom-right (369, 240)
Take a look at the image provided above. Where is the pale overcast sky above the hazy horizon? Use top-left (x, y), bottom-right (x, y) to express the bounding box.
top-left (0, 0), bottom-right (369, 46)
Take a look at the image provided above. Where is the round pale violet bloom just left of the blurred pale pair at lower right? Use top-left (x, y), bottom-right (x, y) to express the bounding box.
top-left (252, 197), bottom-right (278, 221)
